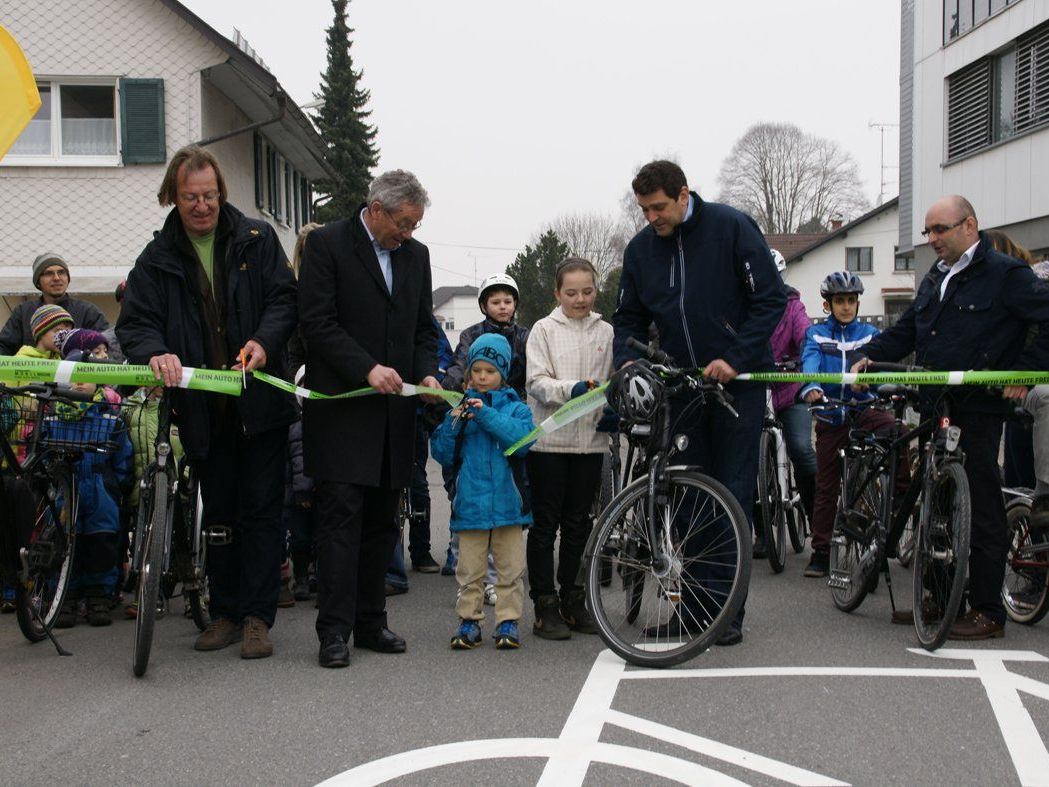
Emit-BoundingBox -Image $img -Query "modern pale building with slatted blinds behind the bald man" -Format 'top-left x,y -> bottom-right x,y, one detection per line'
899,0 -> 1049,275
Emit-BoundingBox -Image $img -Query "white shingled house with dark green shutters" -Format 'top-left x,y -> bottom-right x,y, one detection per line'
0,0 -> 336,321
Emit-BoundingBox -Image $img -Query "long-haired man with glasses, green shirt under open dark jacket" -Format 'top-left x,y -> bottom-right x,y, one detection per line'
116,146 -> 296,658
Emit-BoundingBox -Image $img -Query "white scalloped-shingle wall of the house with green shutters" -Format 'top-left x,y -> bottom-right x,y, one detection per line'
0,0 -> 306,319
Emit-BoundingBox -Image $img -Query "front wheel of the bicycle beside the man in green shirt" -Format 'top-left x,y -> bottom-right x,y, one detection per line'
132,471 -> 170,678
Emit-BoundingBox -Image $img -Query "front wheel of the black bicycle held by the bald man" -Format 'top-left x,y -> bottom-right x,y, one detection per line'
913,462 -> 970,651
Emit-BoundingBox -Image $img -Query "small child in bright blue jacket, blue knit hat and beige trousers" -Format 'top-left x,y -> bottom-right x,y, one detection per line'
431,334 -> 532,651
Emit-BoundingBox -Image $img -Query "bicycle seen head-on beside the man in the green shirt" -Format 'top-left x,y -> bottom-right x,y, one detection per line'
130,389 -> 205,678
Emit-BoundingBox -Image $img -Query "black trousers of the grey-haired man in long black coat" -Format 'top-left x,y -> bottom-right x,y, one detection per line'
314,481 -> 401,640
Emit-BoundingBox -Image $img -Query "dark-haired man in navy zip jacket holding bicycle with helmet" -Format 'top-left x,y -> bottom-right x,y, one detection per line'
612,161 -> 787,644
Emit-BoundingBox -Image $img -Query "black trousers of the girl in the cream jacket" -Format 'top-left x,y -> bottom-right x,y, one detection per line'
527,451 -> 604,600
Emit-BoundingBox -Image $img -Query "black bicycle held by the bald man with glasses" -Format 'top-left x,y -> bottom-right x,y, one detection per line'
814,363 -> 970,651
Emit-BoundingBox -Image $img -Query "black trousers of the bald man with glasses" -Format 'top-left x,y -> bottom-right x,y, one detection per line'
950,412 -> 1009,624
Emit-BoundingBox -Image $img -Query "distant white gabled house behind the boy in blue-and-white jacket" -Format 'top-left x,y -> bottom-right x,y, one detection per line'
785,198 -> 914,323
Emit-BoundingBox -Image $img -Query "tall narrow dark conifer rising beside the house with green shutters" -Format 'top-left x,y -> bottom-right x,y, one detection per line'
315,0 -> 379,221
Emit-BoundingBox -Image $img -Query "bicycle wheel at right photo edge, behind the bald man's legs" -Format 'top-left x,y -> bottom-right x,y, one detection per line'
1002,498 -> 1049,625
